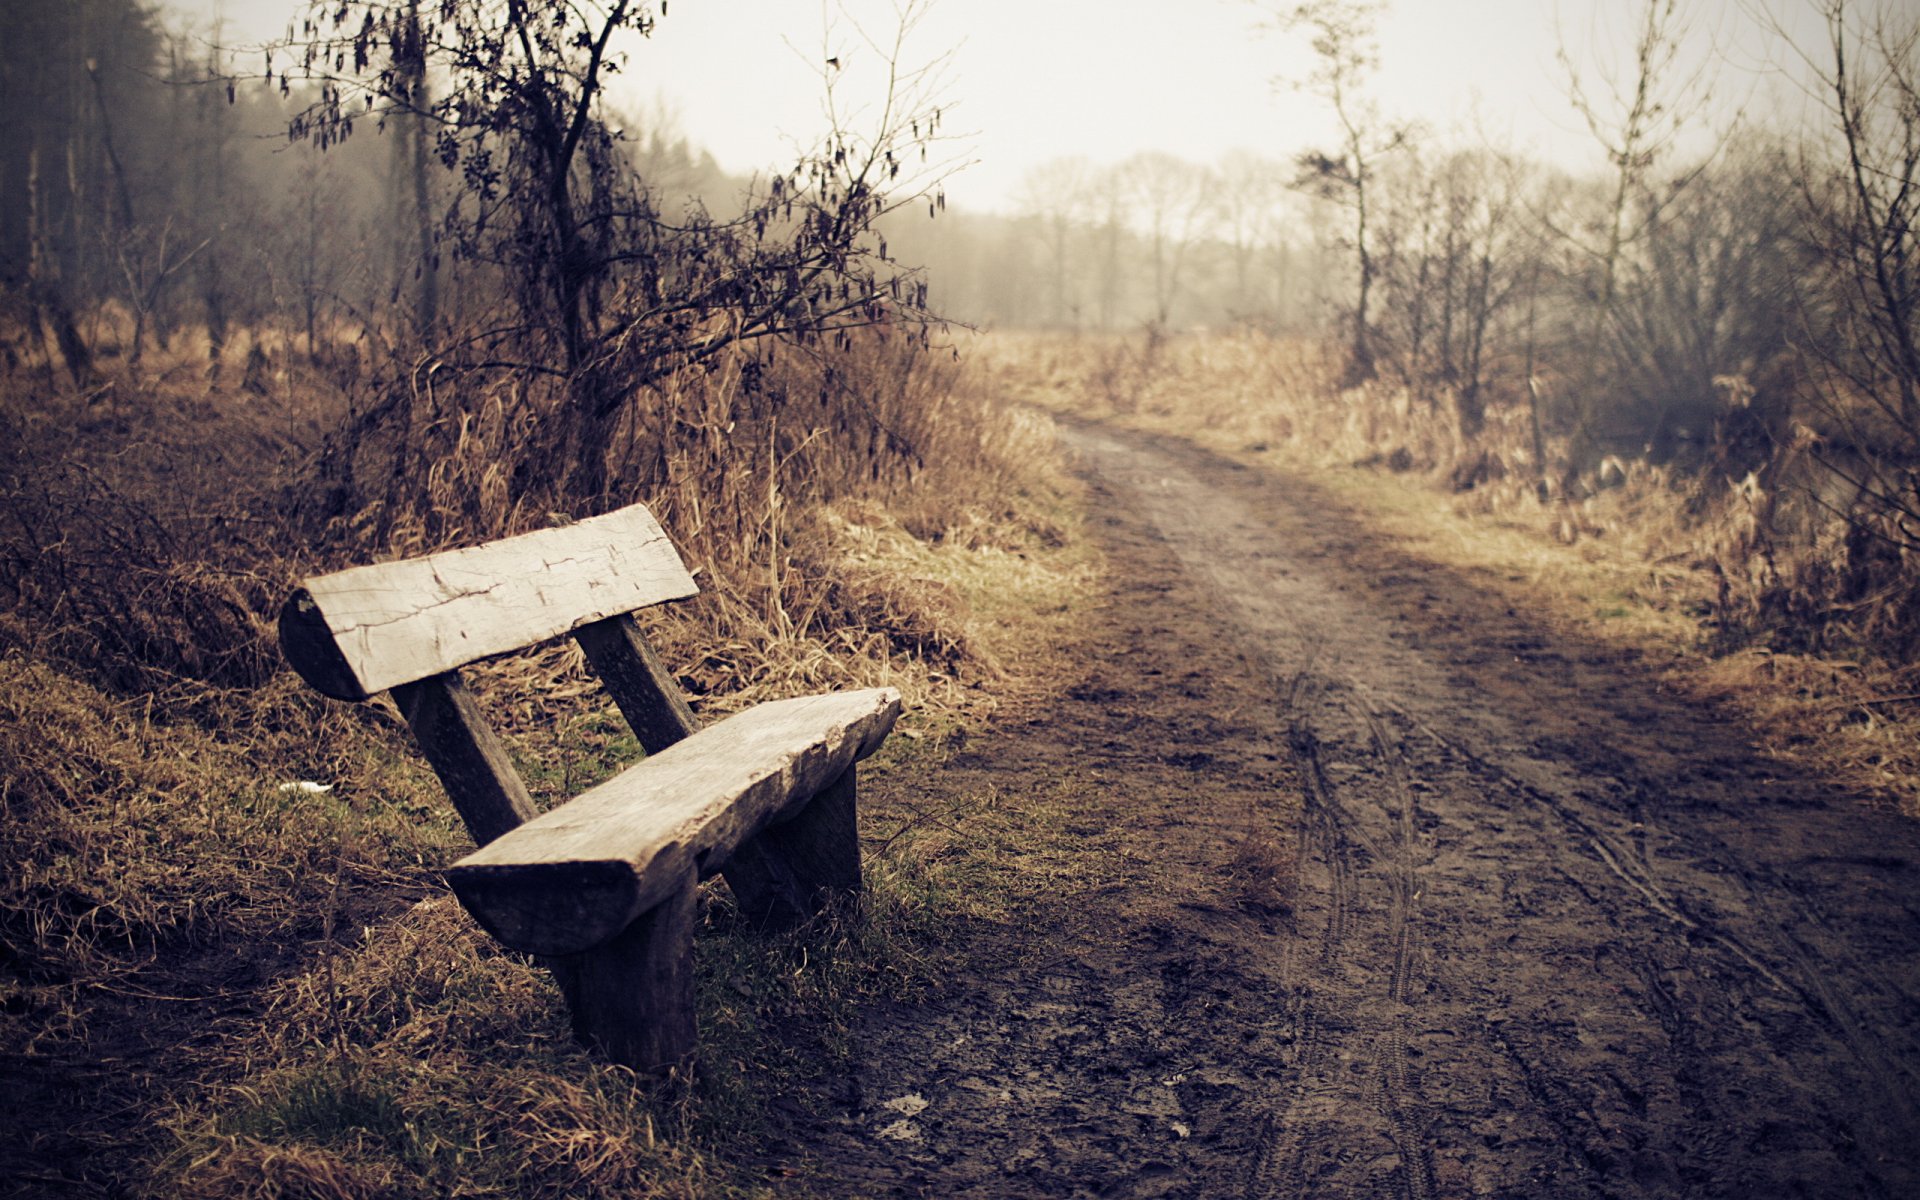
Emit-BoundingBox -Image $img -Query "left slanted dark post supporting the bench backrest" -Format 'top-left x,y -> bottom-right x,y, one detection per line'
394,672 -> 536,847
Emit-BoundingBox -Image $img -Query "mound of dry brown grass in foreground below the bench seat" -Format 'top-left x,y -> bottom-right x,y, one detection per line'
148,897 -> 735,1198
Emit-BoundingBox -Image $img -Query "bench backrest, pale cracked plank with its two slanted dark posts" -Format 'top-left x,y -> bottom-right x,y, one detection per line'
280,505 -> 699,845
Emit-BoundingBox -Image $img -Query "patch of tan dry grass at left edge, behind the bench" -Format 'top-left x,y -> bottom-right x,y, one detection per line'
0,655 -> 455,1050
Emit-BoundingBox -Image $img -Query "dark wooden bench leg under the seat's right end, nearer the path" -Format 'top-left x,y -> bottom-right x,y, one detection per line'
722,766 -> 860,929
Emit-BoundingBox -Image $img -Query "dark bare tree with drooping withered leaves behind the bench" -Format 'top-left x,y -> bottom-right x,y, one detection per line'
269,0 -> 945,503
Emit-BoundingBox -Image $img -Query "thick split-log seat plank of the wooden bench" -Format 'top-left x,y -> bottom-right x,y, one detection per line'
447,687 -> 900,954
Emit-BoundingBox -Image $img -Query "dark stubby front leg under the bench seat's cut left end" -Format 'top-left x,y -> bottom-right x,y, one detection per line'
553,870 -> 697,1073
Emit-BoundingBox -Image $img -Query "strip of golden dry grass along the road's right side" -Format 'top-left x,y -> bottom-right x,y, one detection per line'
979,334 -> 1920,814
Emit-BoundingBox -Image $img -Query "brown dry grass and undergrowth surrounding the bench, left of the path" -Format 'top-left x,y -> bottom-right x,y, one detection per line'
0,322 -> 1096,1196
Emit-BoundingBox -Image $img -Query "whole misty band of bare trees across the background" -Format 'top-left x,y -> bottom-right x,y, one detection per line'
0,0 -> 1920,511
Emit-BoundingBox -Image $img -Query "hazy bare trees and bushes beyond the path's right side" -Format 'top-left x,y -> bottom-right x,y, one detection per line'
913,0 -> 1920,499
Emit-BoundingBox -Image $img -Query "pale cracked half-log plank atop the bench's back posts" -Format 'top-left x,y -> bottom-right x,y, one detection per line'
280,505 -> 699,701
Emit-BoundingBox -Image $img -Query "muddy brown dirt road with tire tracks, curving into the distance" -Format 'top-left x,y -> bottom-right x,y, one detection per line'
785,426 -> 1920,1198
